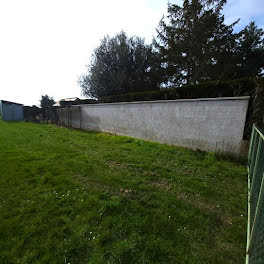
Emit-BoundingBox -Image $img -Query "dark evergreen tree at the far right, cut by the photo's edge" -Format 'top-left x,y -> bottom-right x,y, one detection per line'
236,22 -> 264,78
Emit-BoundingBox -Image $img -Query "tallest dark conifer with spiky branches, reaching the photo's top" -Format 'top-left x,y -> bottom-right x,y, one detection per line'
155,0 -> 237,85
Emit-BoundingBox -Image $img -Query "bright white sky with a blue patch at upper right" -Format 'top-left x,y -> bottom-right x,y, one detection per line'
0,0 -> 264,105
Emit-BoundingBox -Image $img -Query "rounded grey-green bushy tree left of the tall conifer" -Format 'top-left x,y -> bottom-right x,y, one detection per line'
78,32 -> 160,98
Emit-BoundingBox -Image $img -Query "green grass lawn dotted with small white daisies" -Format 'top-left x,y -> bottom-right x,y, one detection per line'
0,121 -> 247,264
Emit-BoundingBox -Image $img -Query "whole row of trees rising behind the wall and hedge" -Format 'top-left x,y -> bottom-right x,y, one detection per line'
78,0 -> 264,98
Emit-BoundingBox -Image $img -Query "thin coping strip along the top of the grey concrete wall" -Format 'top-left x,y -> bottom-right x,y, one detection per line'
67,96 -> 250,107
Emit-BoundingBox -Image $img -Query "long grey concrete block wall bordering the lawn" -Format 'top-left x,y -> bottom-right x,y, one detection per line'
57,97 -> 249,154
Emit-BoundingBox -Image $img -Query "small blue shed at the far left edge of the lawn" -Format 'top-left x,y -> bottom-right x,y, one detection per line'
0,100 -> 24,121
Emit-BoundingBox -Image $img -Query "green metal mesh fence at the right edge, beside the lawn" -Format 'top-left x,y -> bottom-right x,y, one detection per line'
246,125 -> 264,264
